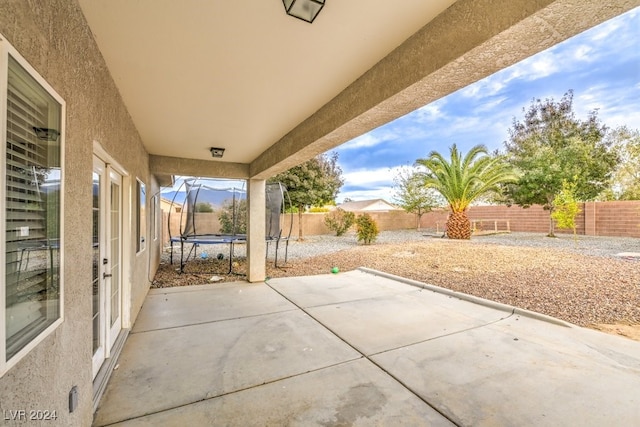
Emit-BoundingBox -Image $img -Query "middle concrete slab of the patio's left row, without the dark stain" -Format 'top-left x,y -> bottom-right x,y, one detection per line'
95,310 -> 360,425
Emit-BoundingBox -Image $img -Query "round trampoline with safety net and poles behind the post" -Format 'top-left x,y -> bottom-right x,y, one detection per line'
168,178 -> 293,274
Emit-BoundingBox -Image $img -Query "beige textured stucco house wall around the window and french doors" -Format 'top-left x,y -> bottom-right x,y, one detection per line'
0,0 -> 161,426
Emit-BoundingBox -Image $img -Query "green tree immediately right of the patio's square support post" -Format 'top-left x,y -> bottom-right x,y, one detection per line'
269,152 -> 344,240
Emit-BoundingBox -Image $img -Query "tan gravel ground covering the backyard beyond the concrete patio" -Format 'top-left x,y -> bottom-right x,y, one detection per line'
154,230 -> 640,338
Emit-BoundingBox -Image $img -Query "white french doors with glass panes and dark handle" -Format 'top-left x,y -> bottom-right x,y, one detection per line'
91,156 -> 123,378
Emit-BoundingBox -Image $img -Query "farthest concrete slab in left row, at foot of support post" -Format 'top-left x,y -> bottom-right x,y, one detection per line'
132,282 -> 296,333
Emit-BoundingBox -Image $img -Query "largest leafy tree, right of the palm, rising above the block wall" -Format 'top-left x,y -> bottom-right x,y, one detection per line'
505,91 -> 618,236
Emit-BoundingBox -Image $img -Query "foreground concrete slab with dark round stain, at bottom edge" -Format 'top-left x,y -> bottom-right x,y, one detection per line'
107,359 -> 454,427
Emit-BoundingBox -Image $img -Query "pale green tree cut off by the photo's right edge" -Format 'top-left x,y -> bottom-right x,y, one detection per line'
600,126 -> 640,200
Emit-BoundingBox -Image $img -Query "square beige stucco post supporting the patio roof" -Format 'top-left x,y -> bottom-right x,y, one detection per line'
247,179 -> 267,283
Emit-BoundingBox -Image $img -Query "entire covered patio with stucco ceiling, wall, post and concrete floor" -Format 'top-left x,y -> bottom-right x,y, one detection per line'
0,0 -> 640,427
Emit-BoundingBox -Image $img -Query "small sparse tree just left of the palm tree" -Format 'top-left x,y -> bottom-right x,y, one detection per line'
393,167 -> 442,228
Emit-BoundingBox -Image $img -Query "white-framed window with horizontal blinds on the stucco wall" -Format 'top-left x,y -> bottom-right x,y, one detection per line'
4,56 -> 62,360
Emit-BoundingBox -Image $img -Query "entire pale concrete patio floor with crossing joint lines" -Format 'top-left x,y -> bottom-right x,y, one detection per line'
94,269 -> 640,426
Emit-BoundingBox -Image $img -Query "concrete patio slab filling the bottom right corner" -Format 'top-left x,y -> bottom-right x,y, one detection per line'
372,316 -> 640,426
